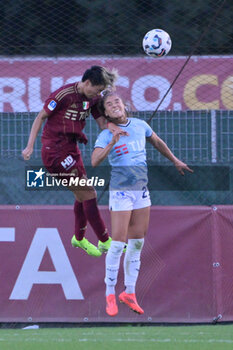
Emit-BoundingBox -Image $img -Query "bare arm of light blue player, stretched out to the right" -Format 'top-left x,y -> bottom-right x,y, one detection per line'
148,132 -> 193,175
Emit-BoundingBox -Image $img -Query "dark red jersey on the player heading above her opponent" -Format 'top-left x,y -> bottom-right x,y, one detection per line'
41,83 -> 101,145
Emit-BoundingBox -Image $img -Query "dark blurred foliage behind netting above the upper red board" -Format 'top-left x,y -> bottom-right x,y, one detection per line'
0,0 -> 233,56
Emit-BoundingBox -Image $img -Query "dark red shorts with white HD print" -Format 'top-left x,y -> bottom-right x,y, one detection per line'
41,145 -> 86,179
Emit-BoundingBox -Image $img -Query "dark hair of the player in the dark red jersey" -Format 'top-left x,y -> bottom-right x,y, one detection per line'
82,66 -> 118,88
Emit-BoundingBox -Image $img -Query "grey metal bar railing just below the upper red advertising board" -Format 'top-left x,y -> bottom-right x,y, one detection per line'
0,111 -> 233,164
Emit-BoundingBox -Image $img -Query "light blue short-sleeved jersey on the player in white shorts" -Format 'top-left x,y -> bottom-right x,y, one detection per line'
95,118 -> 153,190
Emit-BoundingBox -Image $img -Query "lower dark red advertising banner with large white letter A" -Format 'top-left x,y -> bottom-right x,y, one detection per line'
0,206 -> 233,323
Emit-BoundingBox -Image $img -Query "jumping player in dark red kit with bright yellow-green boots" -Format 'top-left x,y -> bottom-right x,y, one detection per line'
22,66 -> 125,256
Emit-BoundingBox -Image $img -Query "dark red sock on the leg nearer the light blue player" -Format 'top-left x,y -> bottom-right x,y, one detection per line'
83,198 -> 109,242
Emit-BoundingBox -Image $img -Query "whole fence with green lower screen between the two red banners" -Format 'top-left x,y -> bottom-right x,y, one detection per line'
0,110 -> 233,205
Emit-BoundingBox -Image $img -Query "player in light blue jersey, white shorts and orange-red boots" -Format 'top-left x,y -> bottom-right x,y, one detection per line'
92,91 -> 193,316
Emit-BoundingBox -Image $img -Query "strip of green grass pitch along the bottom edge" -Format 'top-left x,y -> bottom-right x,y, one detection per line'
0,324 -> 233,350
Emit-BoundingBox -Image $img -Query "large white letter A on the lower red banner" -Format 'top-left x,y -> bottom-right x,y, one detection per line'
9,228 -> 84,300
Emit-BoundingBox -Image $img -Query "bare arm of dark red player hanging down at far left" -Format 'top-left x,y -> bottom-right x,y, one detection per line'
22,109 -> 48,160
